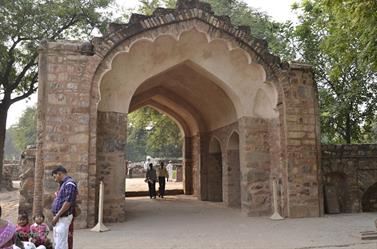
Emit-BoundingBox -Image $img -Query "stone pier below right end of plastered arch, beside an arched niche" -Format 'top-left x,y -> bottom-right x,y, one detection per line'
239,117 -> 272,216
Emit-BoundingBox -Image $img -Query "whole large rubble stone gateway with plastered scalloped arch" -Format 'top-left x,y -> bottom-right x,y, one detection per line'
34,0 -> 323,227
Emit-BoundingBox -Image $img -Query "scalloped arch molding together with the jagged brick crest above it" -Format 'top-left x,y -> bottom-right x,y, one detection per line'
92,0 -> 288,120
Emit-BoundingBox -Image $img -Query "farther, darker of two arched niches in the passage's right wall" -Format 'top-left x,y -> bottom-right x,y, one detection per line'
206,138 -> 223,201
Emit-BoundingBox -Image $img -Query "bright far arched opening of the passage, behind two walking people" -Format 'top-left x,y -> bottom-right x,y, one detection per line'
126,106 -> 185,197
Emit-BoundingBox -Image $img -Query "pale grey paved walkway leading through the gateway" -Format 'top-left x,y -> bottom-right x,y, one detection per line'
75,196 -> 377,249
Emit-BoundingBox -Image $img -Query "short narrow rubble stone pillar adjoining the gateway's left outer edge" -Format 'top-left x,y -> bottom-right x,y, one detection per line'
18,147 -> 36,215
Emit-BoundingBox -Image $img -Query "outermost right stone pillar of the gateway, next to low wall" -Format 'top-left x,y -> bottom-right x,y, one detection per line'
285,64 -> 322,217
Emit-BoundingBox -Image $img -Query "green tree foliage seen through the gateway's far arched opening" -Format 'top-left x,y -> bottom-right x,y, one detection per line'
126,107 -> 182,161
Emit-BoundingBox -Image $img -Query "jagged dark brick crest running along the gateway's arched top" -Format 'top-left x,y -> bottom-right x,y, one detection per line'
92,0 -> 283,78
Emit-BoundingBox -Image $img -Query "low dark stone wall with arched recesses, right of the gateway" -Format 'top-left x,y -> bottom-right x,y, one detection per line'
322,144 -> 377,213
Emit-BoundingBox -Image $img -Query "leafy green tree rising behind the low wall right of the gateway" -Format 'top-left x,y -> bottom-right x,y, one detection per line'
289,0 -> 377,143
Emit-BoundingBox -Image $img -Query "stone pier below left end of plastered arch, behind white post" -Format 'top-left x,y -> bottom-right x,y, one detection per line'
97,111 -> 127,222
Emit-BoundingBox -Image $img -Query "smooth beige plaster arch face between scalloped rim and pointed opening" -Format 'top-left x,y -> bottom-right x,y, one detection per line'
95,27 -> 276,121
